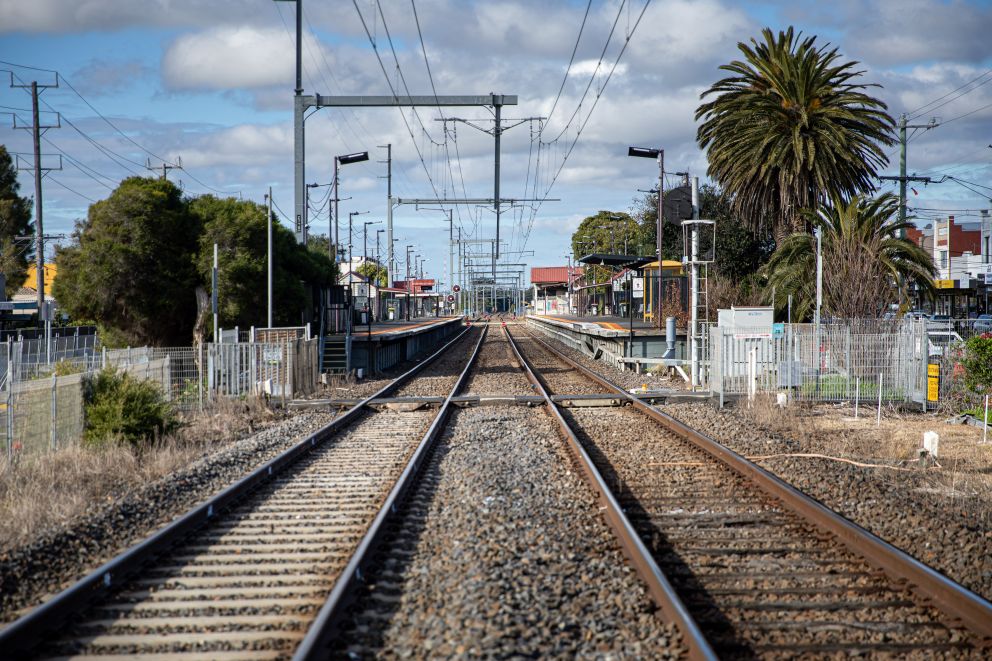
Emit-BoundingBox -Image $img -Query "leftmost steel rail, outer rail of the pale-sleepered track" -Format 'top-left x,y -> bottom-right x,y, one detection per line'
0,327 -> 471,652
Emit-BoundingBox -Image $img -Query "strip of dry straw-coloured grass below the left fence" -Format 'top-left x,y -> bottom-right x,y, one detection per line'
0,400 -> 275,551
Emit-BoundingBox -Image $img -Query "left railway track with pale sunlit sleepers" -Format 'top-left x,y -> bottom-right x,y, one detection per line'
0,322 -> 485,659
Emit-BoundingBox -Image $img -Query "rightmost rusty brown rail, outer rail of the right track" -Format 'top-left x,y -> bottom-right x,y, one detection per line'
532,328 -> 992,647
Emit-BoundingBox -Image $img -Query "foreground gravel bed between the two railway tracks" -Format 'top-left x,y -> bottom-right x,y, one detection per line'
339,407 -> 683,658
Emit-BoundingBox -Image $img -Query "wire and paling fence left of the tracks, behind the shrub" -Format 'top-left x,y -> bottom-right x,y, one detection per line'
0,338 -> 318,458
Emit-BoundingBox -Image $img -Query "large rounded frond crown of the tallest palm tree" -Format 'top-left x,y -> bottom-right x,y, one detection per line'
696,27 -> 894,241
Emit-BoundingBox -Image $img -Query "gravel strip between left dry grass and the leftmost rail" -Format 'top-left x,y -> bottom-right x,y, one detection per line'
0,410 -> 334,622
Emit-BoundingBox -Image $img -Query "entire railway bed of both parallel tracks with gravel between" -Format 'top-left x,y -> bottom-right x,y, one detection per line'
7,318 -> 992,659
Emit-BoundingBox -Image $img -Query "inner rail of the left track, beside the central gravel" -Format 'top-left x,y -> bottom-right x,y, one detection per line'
293,326 -> 489,661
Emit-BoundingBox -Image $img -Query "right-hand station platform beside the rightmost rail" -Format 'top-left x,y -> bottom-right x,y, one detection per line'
527,315 -> 688,372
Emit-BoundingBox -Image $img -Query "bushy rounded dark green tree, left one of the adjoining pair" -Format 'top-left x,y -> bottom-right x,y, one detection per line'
54,177 -> 201,346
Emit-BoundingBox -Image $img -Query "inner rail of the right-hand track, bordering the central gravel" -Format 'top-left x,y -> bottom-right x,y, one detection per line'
503,326 -> 718,659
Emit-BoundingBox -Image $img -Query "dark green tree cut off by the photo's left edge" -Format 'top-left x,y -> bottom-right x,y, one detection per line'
0,145 -> 34,298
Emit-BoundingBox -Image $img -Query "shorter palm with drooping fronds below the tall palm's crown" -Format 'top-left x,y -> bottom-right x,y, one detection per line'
765,193 -> 937,319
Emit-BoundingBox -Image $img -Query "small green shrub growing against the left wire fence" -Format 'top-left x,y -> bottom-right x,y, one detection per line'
83,367 -> 178,446
